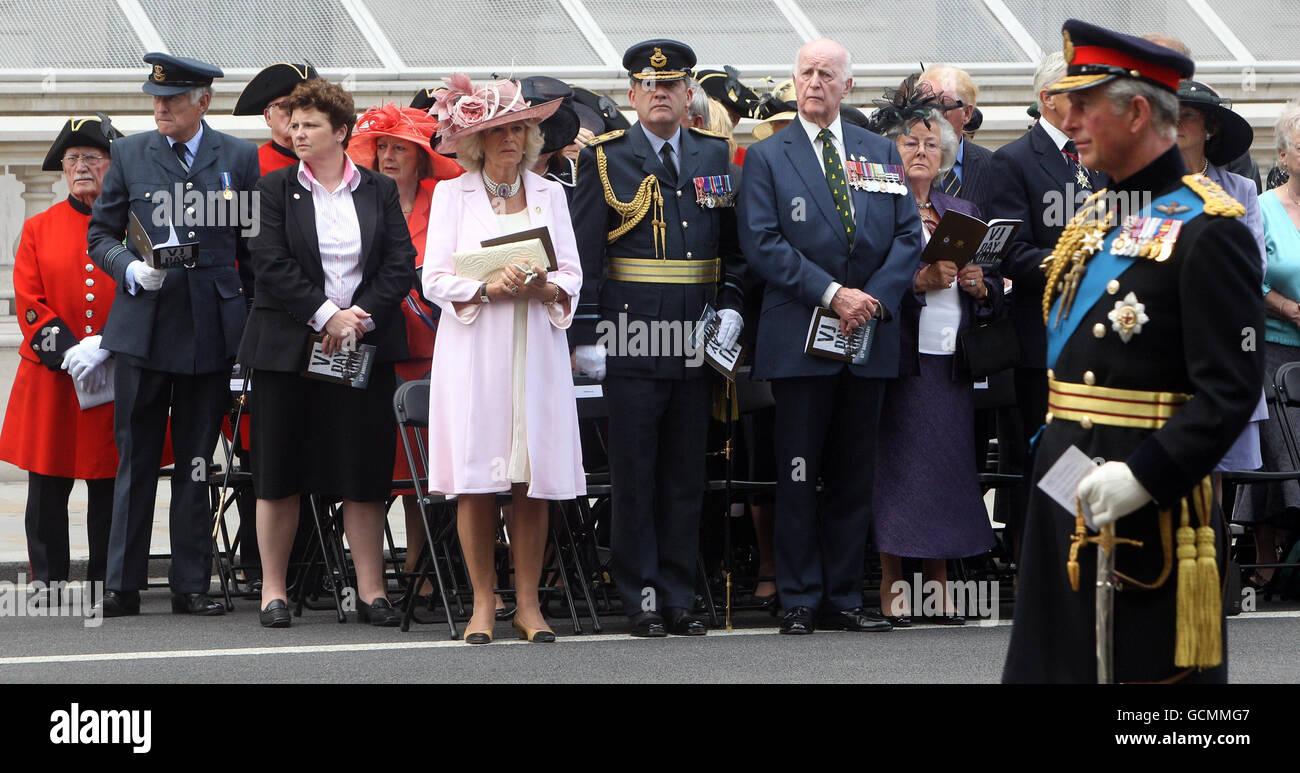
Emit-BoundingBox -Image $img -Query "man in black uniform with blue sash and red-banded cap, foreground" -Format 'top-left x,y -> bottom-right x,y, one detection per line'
1004,19 -> 1264,682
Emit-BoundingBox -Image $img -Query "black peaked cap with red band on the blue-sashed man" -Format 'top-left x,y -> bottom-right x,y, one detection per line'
1048,18 -> 1196,94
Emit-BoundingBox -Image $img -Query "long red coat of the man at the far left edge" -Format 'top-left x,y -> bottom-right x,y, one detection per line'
0,199 -> 117,479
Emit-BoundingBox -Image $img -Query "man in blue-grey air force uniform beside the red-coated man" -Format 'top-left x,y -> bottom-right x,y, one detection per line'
86,53 -> 259,617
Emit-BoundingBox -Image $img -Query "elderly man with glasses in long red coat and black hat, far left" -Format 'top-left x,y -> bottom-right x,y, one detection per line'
0,114 -> 122,585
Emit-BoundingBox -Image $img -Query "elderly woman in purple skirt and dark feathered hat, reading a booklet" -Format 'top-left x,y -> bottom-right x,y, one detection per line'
872,86 -> 1002,626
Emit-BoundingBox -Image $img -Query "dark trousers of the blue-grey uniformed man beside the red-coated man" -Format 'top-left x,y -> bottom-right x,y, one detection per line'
105,357 -> 230,594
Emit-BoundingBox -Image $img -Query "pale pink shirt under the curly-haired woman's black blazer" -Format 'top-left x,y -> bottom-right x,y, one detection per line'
298,156 -> 374,333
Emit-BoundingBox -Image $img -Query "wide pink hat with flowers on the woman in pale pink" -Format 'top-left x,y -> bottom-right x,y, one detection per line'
429,73 -> 564,153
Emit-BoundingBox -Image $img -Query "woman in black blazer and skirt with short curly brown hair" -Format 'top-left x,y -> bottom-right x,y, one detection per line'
239,79 -> 415,627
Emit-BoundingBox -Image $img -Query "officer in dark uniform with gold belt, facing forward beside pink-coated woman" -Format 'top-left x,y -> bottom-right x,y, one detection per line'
571,40 -> 742,637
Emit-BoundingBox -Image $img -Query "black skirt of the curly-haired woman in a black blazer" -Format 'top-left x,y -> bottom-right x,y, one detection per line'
248,362 -> 397,501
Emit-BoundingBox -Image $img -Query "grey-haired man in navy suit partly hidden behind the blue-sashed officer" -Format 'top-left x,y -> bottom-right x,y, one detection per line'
983,52 -> 1105,548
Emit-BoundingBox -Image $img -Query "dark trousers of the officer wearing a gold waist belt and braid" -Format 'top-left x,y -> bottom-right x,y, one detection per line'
605,375 -> 711,616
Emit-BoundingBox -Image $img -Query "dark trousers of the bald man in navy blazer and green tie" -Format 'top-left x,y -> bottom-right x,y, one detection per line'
772,368 -> 884,612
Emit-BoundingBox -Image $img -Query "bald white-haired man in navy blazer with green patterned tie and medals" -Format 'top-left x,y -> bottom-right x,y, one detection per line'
740,39 -> 920,634
